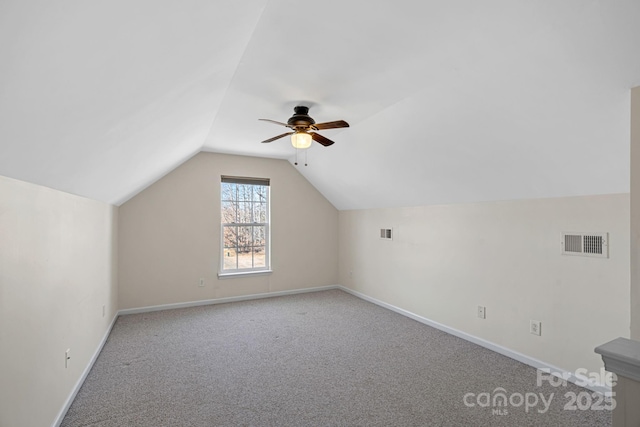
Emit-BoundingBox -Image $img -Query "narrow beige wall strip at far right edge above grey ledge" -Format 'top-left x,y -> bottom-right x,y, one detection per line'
632,87 -> 640,341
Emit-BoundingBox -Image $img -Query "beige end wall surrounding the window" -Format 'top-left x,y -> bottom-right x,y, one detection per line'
119,153 -> 338,309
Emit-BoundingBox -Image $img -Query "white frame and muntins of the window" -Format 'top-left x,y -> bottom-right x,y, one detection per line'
218,176 -> 271,278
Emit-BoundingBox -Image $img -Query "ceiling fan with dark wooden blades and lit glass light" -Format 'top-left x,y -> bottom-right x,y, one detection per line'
260,105 -> 349,148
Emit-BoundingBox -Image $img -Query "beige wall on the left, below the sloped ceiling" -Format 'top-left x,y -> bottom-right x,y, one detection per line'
0,177 -> 117,427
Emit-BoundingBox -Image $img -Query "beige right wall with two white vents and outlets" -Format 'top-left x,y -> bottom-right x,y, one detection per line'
339,194 -> 629,378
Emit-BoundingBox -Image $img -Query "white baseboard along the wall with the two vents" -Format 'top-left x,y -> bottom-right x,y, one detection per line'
337,285 -> 611,395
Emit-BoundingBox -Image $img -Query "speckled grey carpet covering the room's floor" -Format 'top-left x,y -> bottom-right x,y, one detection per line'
62,290 -> 611,427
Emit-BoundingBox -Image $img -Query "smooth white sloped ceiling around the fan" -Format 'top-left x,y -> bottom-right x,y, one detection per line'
0,0 -> 640,209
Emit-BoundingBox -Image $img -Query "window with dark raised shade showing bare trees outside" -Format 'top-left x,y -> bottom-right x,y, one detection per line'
220,176 -> 270,274
